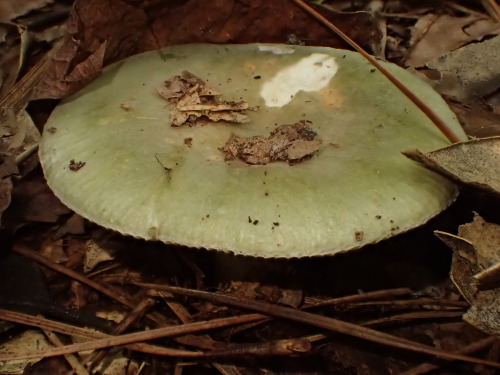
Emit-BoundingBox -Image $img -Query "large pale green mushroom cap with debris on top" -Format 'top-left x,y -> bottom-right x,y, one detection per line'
39,44 -> 466,258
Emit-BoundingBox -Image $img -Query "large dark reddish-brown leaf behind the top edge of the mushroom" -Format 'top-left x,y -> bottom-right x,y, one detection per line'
33,0 -> 381,99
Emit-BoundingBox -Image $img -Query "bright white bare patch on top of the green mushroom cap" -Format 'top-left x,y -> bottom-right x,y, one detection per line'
260,53 -> 339,107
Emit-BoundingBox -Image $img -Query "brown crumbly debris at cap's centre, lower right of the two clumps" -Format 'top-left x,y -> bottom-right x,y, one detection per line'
220,121 -> 321,164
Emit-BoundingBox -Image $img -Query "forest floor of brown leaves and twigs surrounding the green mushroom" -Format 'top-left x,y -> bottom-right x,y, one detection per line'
0,0 -> 500,375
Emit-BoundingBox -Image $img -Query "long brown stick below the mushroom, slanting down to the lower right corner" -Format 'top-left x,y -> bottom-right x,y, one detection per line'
140,283 -> 500,368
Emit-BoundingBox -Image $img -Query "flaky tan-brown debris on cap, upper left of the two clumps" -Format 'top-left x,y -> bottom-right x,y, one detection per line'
156,71 -> 253,126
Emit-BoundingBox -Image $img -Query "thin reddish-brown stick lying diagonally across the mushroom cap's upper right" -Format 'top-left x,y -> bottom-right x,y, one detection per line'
292,0 -> 461,143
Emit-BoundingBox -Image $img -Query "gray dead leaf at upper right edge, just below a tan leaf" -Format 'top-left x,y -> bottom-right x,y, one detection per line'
427,35 -> 500,103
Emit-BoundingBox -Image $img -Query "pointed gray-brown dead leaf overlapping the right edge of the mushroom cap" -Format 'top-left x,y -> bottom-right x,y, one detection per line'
403,136 -> 500,194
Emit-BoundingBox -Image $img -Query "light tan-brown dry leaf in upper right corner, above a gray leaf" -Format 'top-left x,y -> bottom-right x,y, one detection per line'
406,14 -> 500,67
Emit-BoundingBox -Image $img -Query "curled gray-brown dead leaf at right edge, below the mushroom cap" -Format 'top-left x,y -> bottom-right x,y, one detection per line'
436,215 -> 500,335
